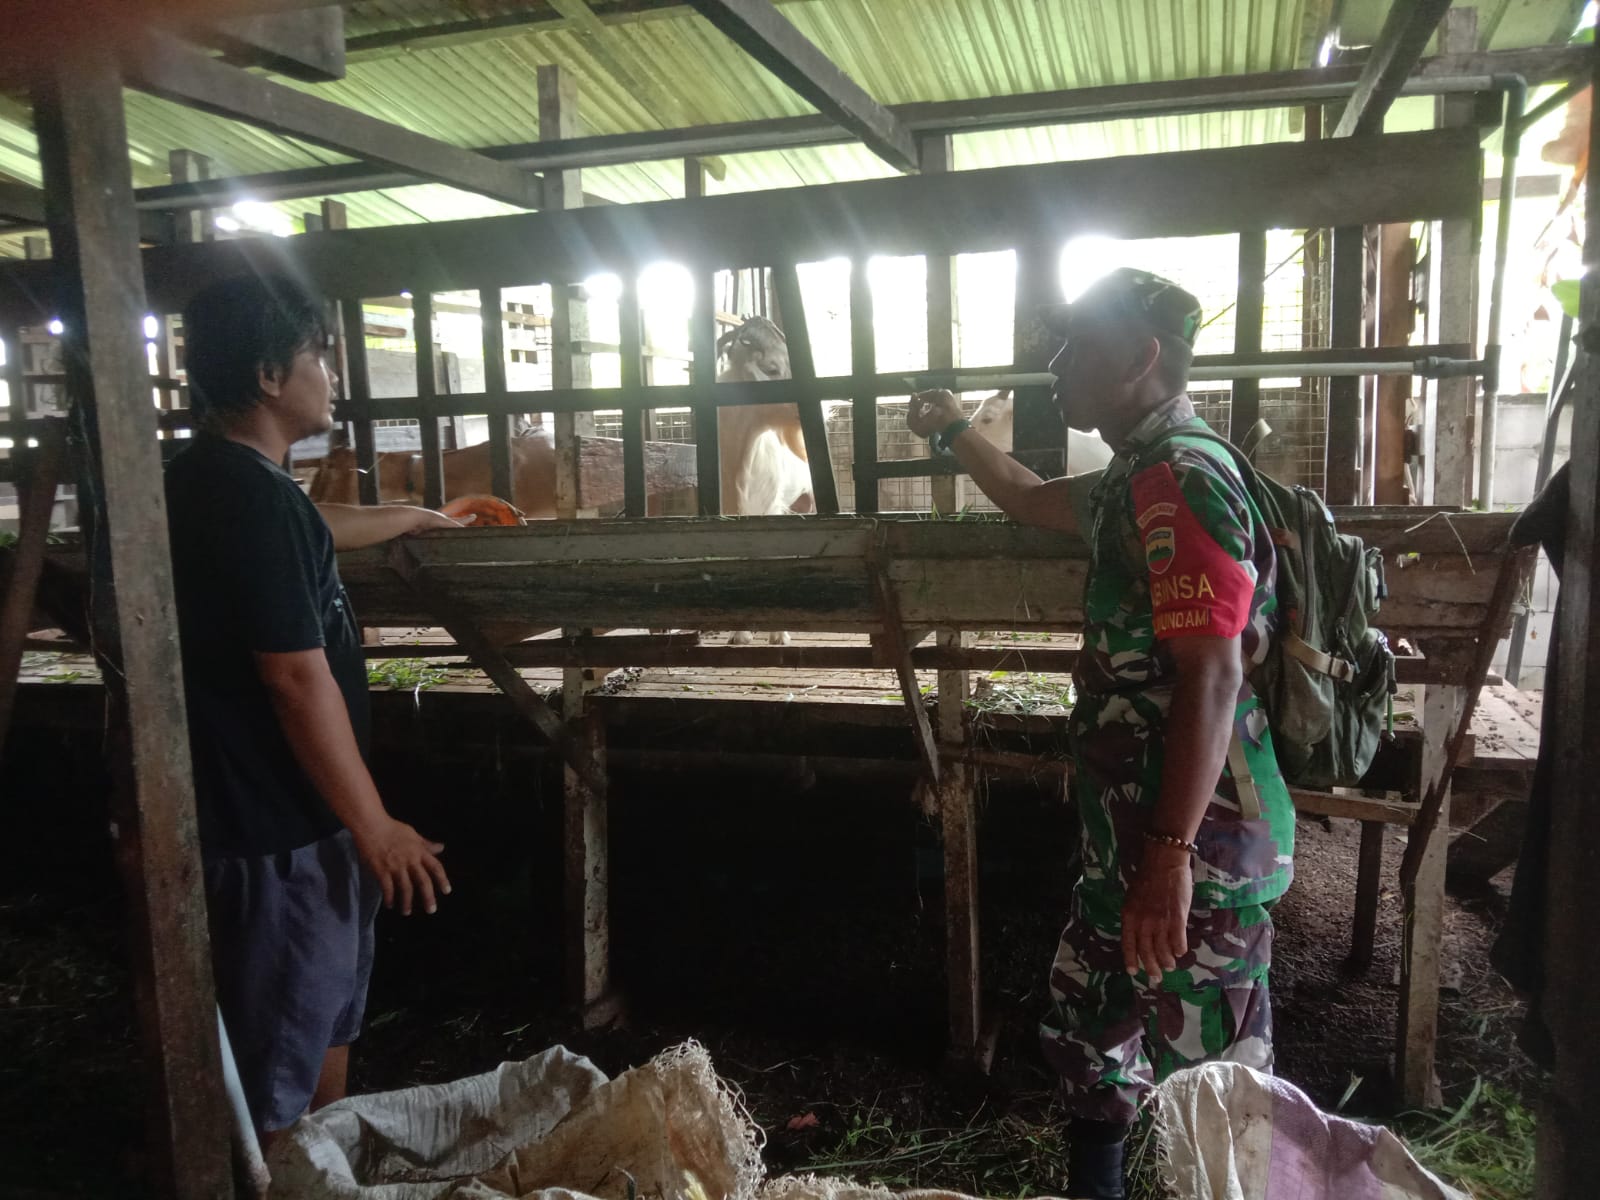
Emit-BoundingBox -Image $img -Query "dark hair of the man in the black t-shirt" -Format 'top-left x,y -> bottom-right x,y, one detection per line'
184,275 -> 330,419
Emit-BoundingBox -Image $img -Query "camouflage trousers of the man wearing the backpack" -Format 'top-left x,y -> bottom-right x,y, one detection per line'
1040,894 -> 1272,1125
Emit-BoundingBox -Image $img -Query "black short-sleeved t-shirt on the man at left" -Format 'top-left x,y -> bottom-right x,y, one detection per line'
166,435 -> 371,856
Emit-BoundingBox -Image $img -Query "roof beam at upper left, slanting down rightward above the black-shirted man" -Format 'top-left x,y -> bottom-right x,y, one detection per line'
123,32 -> 544,208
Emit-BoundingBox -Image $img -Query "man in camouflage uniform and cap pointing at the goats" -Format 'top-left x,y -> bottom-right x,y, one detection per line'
910,269 -> 1294,1197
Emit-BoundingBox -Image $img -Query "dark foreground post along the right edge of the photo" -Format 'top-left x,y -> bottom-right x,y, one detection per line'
1534,28 -> 1600,1200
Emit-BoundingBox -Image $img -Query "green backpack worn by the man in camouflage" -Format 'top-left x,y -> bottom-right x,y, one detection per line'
1134,427 -> 1395,787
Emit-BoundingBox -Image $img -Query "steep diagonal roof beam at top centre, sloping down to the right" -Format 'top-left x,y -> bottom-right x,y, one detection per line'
690,0 -> 917,171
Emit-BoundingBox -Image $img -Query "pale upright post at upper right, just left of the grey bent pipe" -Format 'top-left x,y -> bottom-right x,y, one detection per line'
1424,8 -> 1483,507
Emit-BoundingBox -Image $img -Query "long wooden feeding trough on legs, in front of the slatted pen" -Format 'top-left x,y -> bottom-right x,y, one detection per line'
324,507 -> 1528,1107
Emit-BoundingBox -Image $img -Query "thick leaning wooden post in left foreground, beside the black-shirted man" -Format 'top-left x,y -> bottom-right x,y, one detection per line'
34,45 -> 234,1200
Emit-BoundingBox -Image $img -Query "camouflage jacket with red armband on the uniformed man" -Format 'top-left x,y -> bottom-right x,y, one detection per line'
1070,397 -> 1294,920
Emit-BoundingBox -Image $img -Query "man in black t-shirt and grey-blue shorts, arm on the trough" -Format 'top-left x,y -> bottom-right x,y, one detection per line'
166,275 -> 456,1136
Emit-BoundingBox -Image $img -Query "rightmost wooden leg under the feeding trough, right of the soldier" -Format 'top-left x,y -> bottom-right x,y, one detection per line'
1395,683 -> 1464,1109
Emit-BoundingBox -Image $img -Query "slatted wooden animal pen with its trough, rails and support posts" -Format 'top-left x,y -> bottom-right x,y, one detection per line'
0,5 -> 1600,1195
